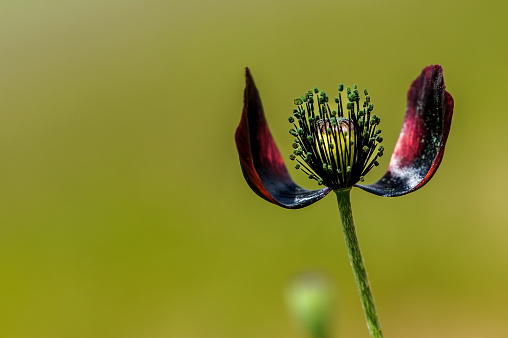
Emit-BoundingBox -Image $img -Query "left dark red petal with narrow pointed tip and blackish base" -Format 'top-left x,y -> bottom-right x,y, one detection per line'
235,68 -> 330,209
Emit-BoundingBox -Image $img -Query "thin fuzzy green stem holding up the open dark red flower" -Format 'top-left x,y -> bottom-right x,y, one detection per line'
335,189 -> 383,338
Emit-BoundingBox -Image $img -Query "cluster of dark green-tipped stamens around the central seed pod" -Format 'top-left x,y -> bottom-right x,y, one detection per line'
289,83 -> 384,190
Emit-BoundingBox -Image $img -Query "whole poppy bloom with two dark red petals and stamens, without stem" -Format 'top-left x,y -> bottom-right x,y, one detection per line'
235,65 -> 453,208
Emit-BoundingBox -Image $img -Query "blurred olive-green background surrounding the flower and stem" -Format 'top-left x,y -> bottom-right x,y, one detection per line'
0,0 -> 508,338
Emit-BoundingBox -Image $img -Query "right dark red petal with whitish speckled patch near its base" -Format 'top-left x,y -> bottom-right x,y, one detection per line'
357,65 -> 453,196
